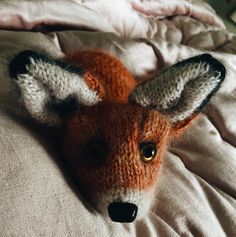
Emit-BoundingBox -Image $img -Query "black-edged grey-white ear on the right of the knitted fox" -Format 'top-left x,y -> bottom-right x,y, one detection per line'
130,54 -> 225,123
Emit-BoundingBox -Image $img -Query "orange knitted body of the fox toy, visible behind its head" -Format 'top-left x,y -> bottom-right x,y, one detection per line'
66,50 -> 137,103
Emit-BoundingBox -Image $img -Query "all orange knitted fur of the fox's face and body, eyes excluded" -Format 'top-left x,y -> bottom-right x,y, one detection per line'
63,50 -> 189,191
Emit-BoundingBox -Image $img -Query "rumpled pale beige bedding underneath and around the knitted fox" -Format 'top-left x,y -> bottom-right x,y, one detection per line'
0,0 -> 236,237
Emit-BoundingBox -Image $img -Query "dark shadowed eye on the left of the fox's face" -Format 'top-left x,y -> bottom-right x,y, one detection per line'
84,140 -> 108,167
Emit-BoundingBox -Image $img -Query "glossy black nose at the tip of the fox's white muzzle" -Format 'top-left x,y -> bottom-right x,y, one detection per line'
108,202 -> 138,223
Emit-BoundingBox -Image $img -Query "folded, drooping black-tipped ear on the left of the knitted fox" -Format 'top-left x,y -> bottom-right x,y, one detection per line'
9,50 -> 100,125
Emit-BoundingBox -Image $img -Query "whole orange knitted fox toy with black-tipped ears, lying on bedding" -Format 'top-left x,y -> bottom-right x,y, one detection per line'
9,50 -> 225,222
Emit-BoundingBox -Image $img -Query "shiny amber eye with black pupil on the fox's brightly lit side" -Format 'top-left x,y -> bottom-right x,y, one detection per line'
139,142 -> 157,162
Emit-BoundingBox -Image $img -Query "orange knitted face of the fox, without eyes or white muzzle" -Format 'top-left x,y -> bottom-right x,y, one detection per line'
67,103 -> 171,191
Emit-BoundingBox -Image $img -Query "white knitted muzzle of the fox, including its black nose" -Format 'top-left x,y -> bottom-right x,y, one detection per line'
87,185 -> 155,223
